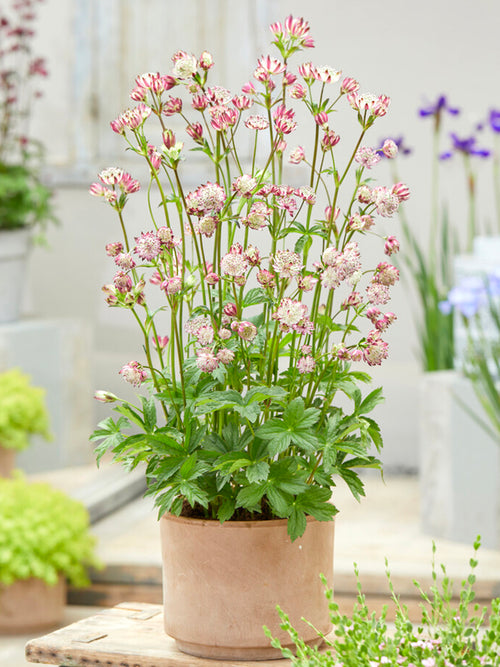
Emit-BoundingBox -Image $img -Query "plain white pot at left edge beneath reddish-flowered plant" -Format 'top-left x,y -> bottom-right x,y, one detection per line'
0,229 -> 31,324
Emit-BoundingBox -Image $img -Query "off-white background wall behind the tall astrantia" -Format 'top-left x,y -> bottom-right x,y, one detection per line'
23,0 -> 500,469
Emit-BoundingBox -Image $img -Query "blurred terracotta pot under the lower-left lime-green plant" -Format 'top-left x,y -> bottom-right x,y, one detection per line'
0,577 -> 66,634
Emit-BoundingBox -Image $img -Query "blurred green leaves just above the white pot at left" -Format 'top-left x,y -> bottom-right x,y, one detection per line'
0,163 -> 55,230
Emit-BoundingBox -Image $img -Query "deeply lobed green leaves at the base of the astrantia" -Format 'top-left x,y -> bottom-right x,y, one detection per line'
91,365 -> 382,539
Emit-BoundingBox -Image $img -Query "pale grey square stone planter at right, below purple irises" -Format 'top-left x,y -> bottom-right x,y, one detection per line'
420,371 -> 500,549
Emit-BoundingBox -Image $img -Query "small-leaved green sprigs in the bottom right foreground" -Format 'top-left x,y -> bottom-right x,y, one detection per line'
264,538 -> 500,667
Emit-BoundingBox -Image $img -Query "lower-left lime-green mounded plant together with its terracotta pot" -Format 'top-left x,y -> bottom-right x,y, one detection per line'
0,477 -> 99,633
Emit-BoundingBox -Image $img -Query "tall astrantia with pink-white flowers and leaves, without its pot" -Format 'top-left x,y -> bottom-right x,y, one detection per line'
90,16 -> 409,538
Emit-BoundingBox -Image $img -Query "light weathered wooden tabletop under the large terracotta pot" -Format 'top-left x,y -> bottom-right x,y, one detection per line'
26,602 -> 290,667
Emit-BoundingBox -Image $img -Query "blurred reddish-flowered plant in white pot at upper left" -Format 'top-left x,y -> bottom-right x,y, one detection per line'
0,0 -> 55,323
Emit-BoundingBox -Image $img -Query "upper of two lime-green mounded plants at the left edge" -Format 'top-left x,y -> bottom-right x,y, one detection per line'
0,368 -> 51,477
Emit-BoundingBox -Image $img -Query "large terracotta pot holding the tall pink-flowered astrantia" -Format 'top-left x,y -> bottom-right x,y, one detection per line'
160,514 -> 334,660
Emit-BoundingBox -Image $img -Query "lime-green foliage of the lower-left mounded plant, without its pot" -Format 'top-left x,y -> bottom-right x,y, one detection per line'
0,477 -> 99,586
